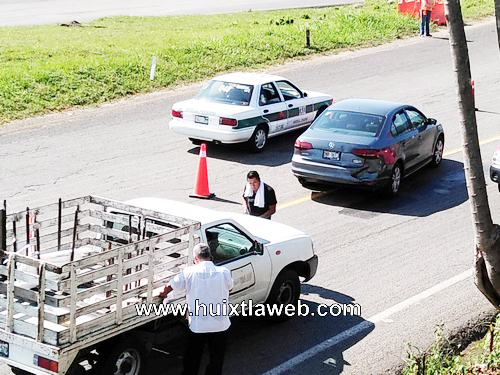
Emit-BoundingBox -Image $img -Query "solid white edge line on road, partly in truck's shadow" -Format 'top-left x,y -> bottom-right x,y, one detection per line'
264,268 -> 473,375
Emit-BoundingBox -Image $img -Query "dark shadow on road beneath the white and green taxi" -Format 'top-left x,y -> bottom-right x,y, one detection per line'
188,129 -> 305,167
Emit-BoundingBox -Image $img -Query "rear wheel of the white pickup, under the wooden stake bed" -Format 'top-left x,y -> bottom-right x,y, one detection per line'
97,338 -> 146,375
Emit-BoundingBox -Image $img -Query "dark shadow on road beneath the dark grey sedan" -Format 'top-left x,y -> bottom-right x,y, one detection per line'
311,159 -> 468,219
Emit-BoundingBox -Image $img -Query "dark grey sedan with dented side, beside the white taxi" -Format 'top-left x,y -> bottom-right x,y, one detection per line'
292,99 -> 444,196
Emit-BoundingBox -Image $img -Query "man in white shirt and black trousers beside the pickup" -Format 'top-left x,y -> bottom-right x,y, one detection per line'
160,243 -> 233,375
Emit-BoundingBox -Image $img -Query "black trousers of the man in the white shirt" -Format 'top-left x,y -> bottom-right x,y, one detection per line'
182,330 -> 227,375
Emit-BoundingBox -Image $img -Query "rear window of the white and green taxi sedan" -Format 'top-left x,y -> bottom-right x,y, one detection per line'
195,80 -> 253,106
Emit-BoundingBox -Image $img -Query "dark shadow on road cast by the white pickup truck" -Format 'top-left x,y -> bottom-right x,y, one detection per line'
146,284 -> 374,375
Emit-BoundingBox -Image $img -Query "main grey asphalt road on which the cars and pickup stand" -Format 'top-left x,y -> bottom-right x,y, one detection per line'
0,20 -> 500,375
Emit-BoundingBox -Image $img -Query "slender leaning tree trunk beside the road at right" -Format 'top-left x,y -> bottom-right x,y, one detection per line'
445,0 -> 500,309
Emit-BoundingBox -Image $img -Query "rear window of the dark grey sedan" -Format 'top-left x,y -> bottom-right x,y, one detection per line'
311,110 -> 384,137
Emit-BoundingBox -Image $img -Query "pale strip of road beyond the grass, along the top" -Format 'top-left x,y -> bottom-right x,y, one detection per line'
0,0 -> 355,26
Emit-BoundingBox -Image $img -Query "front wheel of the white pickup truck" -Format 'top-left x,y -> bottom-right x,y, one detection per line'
266,270 -> 300,323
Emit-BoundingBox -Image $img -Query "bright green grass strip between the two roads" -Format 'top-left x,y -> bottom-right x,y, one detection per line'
0,0 -> 493,124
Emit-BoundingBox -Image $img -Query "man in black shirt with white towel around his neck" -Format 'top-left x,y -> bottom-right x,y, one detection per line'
243,171 -> 277,219
